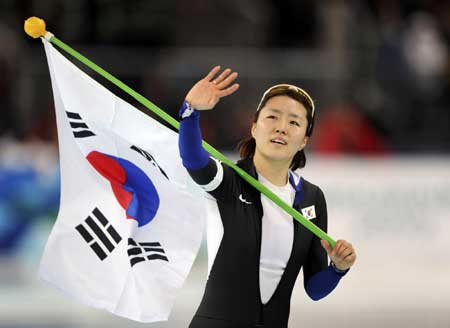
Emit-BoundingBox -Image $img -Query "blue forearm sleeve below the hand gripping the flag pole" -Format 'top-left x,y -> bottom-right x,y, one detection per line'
305,265 -> 349,301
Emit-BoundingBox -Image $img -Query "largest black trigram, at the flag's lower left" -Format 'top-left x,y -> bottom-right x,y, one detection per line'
75,208 -> 122,261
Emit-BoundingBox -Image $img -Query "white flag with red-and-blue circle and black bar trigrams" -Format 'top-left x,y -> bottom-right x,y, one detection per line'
40,40 -> 205,322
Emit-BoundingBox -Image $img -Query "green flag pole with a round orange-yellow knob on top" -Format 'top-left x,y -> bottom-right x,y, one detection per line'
24,17 -> 336,247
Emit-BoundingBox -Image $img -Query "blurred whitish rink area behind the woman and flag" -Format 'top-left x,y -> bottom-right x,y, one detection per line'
0,156 -> 450,328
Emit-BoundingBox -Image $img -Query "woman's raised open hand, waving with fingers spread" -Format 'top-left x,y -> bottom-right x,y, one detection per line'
186,66 -> 239,110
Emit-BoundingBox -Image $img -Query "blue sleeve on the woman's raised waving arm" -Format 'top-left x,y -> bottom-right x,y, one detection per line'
178,101 -> 209,170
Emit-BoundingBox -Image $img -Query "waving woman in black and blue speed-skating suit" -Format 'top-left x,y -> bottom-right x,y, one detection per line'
179,66 -> 356,328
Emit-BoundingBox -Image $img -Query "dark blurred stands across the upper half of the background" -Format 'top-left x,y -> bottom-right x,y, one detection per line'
0,0 -> 450,157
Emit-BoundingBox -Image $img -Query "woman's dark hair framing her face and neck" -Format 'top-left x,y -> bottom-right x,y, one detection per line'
238,89 -> 314,170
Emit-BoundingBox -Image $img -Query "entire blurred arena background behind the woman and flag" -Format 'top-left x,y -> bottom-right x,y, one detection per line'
0,0 -> 450,328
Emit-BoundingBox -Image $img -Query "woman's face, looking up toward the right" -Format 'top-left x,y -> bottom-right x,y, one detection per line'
252,95 -> 308,163
